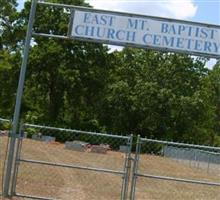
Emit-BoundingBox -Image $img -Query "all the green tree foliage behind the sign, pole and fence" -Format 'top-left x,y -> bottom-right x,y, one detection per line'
0,0 -> 220,147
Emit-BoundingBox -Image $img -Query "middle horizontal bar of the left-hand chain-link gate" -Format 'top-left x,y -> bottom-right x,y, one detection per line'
18,159 -> 125,175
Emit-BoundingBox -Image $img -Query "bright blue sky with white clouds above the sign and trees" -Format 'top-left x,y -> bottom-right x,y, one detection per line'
18,0 -> 220,68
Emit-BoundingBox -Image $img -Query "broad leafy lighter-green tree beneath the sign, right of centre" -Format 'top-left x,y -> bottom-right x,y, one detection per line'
101,48 -> 216,143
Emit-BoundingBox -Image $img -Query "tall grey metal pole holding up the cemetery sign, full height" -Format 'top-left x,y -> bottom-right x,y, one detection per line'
3,0 -> 37,197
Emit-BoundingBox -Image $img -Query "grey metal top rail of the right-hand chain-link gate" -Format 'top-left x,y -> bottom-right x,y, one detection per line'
140,138 -> 220,151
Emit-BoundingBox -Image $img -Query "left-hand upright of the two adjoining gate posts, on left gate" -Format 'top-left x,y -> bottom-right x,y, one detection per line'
121,135 -> 133,200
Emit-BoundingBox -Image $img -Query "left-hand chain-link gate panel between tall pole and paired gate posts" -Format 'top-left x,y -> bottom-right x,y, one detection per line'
14,124 -> 132,200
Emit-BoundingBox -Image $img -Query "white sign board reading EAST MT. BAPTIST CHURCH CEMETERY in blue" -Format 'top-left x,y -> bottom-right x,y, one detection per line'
69,9 -> 220,58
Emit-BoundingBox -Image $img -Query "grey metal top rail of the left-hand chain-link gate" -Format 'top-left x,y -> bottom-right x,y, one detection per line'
24,123 -> 131,139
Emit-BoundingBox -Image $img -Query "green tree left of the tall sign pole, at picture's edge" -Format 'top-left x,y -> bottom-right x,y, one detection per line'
0,0 -> 20,118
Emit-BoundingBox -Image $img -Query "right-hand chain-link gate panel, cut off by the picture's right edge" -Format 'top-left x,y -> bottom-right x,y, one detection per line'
131,137 -> 220,200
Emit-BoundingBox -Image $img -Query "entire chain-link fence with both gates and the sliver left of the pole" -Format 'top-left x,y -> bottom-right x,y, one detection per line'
0,118 -> 220,200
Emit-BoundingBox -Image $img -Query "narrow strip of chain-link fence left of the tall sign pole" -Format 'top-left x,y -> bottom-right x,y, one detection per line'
0,118 -> 11,196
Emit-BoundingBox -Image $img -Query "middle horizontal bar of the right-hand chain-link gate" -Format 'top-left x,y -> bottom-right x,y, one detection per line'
135,173 -> 220,186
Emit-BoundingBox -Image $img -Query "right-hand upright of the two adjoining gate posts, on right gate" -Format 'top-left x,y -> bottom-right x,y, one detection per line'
130,135 -> 141,200
